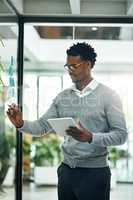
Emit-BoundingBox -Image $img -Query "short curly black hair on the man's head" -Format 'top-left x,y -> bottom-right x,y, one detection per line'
67,42 -> 97,68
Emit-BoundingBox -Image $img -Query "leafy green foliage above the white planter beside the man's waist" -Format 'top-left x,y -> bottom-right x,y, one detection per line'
33,134 -> 62,166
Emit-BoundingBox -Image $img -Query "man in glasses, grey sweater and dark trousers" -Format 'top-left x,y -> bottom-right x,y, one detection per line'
7,43 -> 127,200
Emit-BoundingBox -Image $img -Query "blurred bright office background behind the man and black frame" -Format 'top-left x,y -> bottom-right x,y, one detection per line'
0,0 -> 133,200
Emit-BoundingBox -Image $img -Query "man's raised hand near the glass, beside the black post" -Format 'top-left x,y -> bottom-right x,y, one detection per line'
7,103 -> 24,128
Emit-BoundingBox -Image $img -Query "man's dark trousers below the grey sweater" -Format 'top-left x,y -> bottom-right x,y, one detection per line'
57,163 -> 111,200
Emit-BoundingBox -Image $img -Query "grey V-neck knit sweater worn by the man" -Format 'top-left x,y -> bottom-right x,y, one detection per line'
19,84 -> 127,168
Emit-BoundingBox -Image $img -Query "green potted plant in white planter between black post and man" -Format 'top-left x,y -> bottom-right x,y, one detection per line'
33,134 -> 62,185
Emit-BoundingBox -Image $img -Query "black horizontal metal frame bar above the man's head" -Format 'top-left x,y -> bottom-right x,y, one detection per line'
23,15 -> 133,24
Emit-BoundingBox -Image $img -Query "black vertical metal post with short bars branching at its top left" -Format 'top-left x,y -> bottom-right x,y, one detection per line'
0,0 -> 24,200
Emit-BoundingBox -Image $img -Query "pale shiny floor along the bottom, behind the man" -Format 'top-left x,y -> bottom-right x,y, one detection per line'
0,184 -> 133,200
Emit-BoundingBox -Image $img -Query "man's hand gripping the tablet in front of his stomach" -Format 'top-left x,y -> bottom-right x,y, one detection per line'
66,121 -> 92,143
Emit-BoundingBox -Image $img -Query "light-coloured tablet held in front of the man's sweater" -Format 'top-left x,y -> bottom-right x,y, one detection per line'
47,117 -> 76,136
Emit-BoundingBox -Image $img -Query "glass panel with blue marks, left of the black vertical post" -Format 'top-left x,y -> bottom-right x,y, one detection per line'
0,23 -> 18,199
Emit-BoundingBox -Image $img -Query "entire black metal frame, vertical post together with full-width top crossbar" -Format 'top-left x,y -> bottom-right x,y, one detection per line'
0,0 -> 133,200
